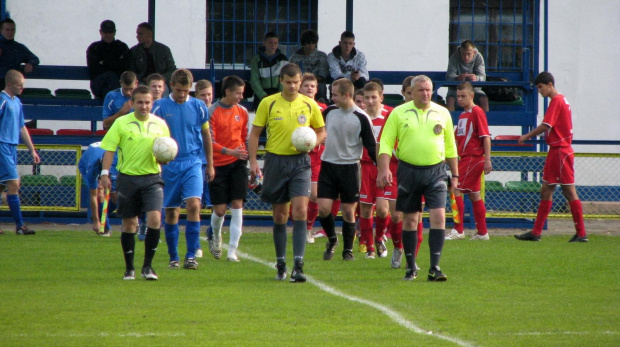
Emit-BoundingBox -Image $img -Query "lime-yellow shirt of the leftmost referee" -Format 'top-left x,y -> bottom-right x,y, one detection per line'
100,112 -> 170,176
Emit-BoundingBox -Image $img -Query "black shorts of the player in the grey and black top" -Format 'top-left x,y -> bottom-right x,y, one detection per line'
317,161 -> 360,203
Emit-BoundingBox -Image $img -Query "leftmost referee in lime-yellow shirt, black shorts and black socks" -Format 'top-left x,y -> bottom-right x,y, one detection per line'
100,86 -> 170,280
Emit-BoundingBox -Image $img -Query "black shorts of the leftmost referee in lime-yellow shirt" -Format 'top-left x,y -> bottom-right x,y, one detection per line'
116,173 -> 164,218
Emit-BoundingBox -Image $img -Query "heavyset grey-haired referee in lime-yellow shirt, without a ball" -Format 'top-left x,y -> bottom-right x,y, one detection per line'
377,75 -> 459,281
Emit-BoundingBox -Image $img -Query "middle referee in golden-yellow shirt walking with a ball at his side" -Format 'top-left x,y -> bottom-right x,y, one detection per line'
248,64 -> 325,282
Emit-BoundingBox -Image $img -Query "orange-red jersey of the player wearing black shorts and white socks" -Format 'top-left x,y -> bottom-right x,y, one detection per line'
209,101 -> 248,166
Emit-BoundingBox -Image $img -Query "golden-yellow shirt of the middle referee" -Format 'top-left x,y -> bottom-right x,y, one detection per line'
252,93 -> 325,155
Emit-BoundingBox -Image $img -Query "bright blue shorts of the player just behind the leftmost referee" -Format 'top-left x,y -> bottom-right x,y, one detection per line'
162,159 -> 204,208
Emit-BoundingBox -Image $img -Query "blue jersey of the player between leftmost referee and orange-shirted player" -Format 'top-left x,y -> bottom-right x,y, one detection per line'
153,94 -> 209,160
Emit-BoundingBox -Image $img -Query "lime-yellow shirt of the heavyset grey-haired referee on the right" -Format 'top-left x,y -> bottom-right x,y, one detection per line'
379,101 -> 457,166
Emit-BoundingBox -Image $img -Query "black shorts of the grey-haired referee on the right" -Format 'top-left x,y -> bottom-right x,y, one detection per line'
396,161 -> 448,213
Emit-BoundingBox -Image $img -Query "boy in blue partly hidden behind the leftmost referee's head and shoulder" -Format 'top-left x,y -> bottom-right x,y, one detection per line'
102,71 -> 138,129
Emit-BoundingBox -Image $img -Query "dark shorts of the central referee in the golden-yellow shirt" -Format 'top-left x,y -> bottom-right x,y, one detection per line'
260,153 -> 312,204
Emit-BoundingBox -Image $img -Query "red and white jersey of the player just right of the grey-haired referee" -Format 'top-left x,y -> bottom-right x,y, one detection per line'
454,105 -> 491,158
